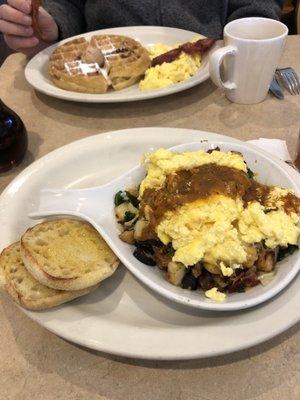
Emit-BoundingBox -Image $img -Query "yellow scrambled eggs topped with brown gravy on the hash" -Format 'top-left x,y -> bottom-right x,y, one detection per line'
140,149 -> 300,268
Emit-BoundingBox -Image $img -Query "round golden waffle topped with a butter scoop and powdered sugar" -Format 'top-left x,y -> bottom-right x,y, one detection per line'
49,35 -> 151,93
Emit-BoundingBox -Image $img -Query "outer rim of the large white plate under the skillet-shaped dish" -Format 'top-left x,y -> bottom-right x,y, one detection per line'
0,128 -> 300,360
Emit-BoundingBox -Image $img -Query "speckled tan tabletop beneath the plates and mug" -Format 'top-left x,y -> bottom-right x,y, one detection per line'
0,36 -> 300,400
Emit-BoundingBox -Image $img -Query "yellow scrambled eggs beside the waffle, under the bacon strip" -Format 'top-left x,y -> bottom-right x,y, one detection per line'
139,37 -> 201,90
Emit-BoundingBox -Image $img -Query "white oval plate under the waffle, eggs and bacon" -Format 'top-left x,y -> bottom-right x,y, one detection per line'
25,26 -> 217,103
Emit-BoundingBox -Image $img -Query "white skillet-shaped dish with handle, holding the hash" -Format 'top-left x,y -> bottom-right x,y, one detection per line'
31,140 -> 300,311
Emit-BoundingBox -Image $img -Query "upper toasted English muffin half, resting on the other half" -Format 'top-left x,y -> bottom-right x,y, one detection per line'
21,219 -> 119,290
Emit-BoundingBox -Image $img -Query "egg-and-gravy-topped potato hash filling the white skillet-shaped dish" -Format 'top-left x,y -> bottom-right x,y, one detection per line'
114,148 -> 300,301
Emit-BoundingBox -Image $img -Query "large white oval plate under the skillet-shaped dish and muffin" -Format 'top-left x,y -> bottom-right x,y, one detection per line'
0,128 -> 300,359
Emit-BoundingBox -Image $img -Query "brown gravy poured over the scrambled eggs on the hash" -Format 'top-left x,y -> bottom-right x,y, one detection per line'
140,164 -> 300,237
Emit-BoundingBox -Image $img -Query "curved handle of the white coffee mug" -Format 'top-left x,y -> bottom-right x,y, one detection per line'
209,46 -> 237,90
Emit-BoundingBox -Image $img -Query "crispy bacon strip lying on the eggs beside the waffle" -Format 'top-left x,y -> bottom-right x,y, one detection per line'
151,38 -> 216,67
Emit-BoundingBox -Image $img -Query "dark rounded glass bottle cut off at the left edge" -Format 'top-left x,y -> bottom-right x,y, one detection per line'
0,100 -> 28,173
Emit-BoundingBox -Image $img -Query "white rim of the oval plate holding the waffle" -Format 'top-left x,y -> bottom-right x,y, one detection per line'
25,25 -> 220,103
